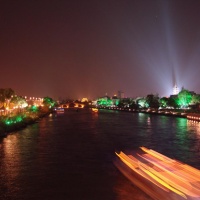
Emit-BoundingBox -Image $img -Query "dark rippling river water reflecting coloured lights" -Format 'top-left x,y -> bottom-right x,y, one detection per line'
0,110 -> 200,200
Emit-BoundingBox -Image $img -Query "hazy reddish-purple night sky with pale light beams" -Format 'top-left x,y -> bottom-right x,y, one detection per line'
0,0 -> 200,99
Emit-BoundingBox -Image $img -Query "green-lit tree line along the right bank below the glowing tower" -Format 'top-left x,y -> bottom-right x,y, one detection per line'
97,88 -> 200,109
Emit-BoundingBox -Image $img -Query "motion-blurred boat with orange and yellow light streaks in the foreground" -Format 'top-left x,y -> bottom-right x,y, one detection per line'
115,147 -> 200,200
